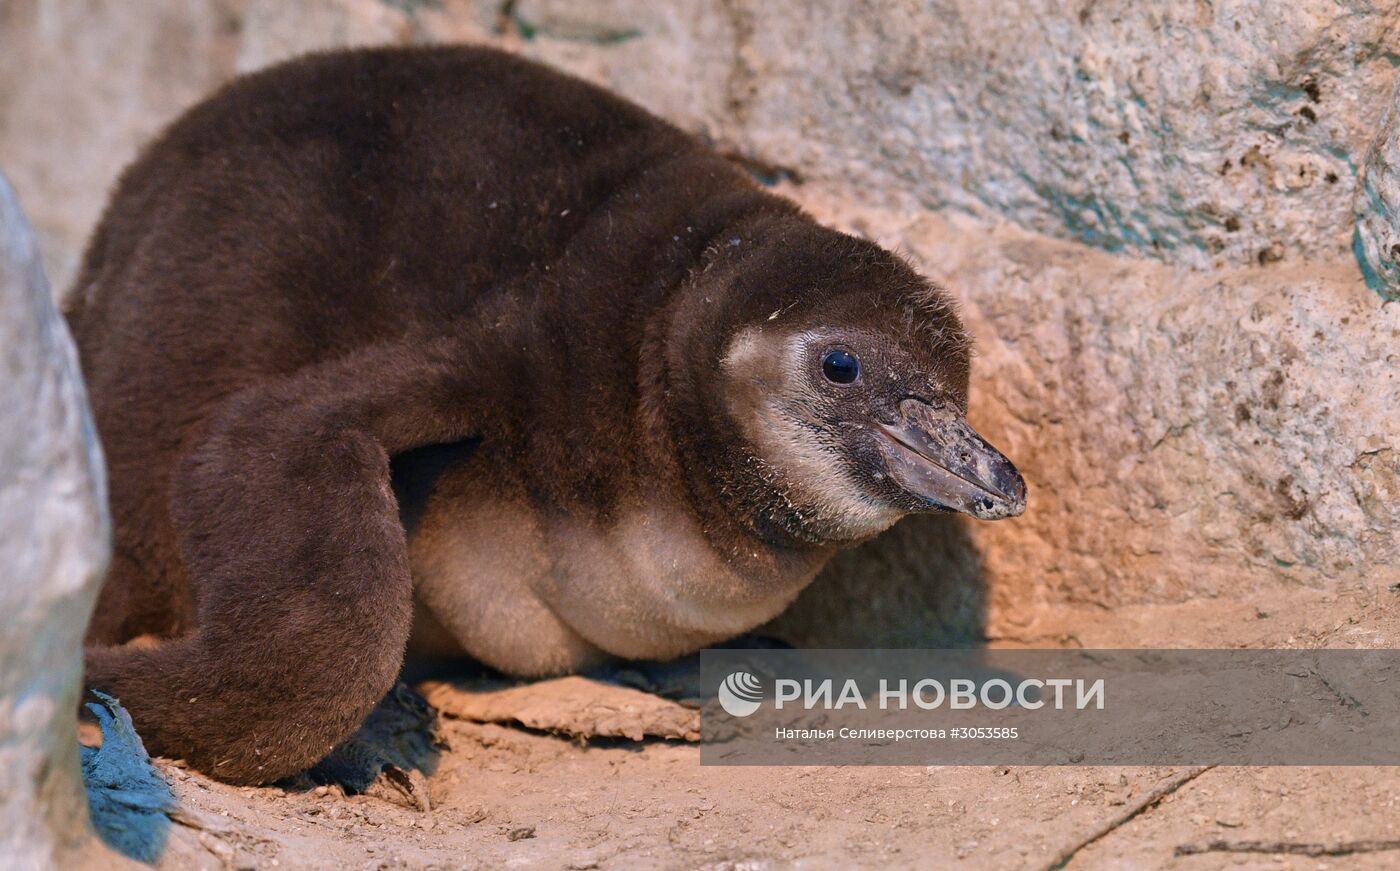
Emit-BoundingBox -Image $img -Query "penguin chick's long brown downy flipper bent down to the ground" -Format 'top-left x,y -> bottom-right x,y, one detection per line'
87,336 -> 490,783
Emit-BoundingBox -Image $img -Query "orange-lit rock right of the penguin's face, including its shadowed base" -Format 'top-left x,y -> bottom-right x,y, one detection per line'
780,196 -> 1400,644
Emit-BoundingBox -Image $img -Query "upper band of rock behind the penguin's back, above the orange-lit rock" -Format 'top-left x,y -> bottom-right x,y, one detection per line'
10,0 -> 1400,287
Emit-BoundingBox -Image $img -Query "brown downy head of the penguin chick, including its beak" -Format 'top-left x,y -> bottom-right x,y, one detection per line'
677,221 -> 1026,543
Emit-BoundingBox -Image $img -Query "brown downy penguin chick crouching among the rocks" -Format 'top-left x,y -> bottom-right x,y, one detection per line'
69,48 -> 1025,783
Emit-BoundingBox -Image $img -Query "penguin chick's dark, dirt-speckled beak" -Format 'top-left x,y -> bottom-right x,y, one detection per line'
879,399 -> 1026,520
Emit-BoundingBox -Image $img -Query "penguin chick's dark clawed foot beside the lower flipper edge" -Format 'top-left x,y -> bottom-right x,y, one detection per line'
284,683 -> 445,811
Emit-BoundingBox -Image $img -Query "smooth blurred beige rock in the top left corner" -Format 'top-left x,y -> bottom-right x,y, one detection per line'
0,0 -> 241,293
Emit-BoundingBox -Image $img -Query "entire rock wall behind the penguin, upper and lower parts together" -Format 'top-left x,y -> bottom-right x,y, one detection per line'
0,0 -> 1400,643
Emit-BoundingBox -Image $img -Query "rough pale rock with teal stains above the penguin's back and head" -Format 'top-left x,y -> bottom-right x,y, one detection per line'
490,0 -> 1400,266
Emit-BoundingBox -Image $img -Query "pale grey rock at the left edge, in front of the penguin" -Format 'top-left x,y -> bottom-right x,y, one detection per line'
0,176 -> 111,868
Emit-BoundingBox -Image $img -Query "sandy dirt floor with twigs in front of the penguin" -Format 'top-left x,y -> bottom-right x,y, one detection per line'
133,590 -> 1400,871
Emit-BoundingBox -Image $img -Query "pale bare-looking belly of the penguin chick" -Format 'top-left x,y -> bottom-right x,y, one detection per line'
409,503 -> 816,676
